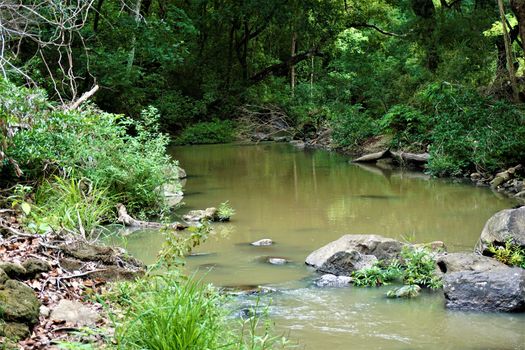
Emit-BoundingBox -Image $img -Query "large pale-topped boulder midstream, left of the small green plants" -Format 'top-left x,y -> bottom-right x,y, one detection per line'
305,235 -> 403,276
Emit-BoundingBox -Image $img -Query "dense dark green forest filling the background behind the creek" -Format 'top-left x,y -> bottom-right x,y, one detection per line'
0,0 -> 525,175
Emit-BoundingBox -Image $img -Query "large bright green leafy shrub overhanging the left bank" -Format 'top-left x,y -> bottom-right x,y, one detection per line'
0,82 -> 177,213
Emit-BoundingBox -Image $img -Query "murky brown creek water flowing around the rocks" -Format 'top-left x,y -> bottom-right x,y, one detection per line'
121,144 -> 525,350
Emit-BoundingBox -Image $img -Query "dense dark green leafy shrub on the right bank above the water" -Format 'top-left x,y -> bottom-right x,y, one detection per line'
417,83 -> 525,176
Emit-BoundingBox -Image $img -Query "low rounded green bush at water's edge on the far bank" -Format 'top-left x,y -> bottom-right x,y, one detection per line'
175,119 -> 235,145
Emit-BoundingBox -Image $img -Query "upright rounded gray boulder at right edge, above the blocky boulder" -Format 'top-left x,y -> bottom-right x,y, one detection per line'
476,207 -> 525,255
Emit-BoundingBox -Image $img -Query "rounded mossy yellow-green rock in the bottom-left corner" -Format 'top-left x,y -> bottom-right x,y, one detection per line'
0,280 -> 40,324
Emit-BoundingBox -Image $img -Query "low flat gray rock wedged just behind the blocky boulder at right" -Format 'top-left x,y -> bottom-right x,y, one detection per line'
436,253 -> 507,273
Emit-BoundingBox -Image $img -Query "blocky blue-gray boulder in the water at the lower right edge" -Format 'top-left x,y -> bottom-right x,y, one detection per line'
443,267 -> 525,312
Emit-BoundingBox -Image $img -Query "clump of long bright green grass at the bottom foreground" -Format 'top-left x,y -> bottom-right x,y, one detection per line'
116,274 -> 228,350
